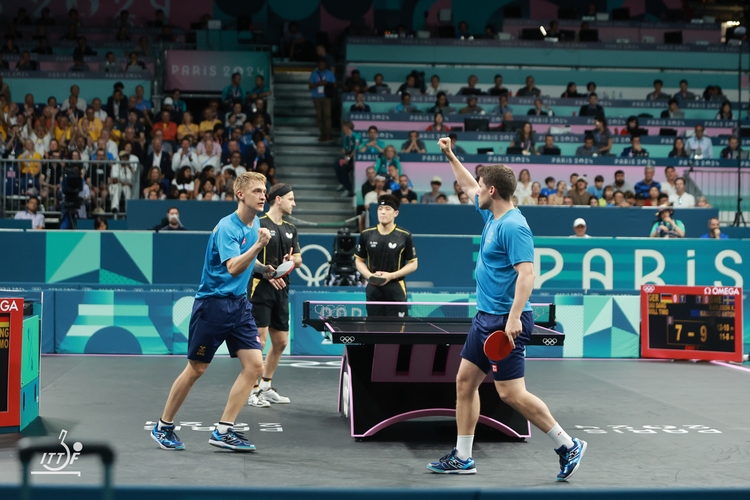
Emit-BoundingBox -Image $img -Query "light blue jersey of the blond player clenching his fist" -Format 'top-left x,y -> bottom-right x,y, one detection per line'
195,212 -> 260,299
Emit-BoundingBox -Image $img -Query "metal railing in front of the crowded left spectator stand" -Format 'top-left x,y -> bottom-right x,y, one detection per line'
0,158 -> 143,217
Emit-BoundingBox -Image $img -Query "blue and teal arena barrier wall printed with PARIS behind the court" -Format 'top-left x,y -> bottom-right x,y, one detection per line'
0,231 -> 750,357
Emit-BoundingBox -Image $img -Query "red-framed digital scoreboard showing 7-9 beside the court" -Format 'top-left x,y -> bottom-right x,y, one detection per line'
641,285 -> 742,362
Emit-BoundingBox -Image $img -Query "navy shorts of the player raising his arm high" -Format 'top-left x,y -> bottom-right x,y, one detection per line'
461,311 -> 534,380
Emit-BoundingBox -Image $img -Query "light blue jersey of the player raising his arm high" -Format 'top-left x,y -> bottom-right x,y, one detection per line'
474,195 -> 534,315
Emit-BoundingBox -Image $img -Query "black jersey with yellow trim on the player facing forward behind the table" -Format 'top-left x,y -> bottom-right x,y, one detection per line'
354,225 -> 417,279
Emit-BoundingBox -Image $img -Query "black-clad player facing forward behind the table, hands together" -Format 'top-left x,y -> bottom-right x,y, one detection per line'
354,194 -> 417,317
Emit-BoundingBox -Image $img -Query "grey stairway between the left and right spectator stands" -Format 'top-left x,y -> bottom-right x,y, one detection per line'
273,66 -> 355,233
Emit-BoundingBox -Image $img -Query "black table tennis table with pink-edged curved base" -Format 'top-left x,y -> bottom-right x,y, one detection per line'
303,301 -> 565,439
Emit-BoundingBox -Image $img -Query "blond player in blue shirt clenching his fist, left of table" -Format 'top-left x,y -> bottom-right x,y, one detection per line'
151,172 -> 283,451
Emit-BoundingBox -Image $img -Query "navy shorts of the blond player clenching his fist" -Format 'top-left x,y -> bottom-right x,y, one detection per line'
188,297 -> 260,363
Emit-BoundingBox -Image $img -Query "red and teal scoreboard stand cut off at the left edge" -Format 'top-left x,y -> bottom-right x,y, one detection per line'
0,298 -> 39,433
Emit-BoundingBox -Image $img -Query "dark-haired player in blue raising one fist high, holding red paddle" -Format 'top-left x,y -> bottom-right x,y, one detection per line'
427,138 -> 586,481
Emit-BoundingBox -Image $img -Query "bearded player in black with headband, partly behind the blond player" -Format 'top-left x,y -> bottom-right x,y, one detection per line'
247,184 -> 302,408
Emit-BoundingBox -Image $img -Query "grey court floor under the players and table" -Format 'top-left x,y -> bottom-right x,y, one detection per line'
0,356 -> 750,489
